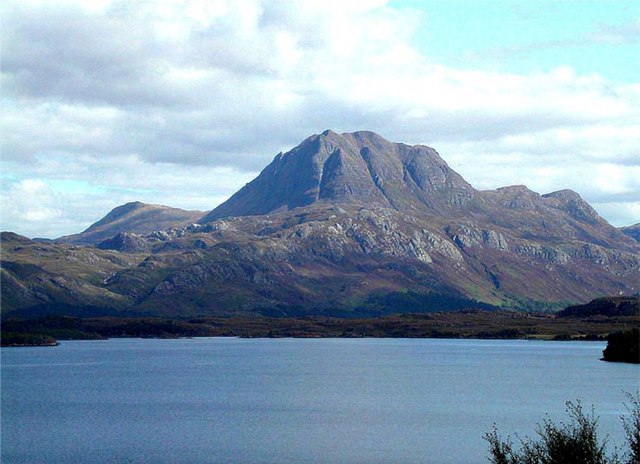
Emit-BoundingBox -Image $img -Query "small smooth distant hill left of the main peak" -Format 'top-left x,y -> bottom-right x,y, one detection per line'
56,201 -> 203,245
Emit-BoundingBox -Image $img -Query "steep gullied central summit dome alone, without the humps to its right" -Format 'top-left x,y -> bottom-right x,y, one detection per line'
200,130 -> 475,222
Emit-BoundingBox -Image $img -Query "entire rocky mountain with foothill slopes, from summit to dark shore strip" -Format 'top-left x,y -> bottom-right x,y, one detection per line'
2,131 -> 640,316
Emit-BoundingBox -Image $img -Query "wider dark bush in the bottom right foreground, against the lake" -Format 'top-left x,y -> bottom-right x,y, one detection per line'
484,401 -> 620,464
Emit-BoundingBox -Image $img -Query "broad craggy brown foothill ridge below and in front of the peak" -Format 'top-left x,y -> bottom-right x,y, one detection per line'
1,206 -> 639,317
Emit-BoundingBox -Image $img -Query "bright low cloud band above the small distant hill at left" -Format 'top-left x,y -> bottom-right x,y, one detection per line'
0,155 -> 255,238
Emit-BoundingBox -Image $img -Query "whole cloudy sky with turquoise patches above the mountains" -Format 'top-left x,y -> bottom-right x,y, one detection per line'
0,0 -> 640,238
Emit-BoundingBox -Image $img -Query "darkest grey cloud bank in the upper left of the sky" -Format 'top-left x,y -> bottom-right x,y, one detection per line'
2,7 -> 255,108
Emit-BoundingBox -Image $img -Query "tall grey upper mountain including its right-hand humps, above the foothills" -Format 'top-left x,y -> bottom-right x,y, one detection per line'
199,131 -> 630,249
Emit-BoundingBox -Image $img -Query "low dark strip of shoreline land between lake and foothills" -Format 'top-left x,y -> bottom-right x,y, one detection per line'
0,308 -> 638,344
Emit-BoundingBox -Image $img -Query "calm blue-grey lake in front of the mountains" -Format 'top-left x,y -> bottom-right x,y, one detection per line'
1,338 -> 640,464
